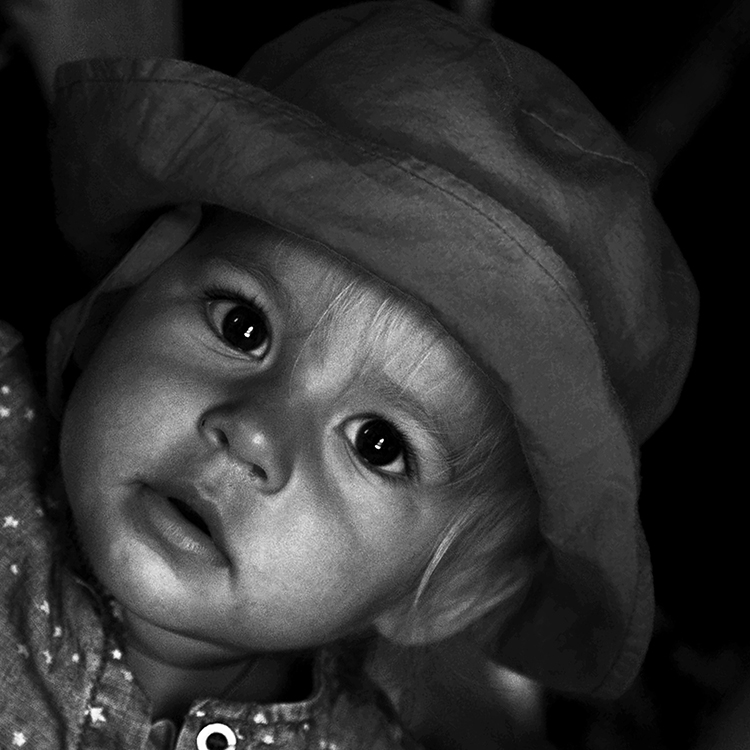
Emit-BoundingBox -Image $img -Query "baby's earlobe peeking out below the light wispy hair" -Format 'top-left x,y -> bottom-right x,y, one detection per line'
374,597 -> 483,646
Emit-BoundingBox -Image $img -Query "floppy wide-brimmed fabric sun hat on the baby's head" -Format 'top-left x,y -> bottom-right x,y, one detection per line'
50,0 -> 697,697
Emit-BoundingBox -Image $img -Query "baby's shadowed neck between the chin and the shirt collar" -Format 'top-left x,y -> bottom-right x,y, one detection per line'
126,618 -> 307,723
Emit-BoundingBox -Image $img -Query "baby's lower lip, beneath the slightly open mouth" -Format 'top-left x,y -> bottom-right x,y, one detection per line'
135,485 -> 228,567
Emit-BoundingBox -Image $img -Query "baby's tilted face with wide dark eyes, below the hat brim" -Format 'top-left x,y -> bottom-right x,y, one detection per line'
62,213 -> 506,650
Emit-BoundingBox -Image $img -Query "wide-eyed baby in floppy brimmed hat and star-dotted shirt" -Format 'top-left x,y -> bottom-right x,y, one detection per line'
0,0 -> 696,750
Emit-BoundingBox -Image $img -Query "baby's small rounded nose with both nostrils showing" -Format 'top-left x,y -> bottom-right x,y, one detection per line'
199,403 -> 295,493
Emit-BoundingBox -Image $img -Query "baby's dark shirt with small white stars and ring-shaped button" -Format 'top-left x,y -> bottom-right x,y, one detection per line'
0,322 -> 417,750
